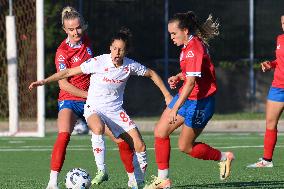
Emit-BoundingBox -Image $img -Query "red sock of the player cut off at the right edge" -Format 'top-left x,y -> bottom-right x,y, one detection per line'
263,129 -> 278,160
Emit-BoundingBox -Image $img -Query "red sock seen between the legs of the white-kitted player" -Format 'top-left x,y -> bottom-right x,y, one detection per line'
117,141 -> 134,173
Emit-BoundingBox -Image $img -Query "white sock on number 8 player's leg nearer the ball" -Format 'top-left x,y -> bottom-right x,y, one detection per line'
91,133 -> 106,172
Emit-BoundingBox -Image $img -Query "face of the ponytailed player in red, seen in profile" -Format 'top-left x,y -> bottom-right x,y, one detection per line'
168,21 -> 188,46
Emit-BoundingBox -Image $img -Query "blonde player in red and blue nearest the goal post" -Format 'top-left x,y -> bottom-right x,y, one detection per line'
44,7 -> 139,189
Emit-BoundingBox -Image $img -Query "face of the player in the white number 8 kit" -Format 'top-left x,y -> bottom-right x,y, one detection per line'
110,39 -> 126,65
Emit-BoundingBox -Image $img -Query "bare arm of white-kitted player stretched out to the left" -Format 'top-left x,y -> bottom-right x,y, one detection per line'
29,66 -> 83,90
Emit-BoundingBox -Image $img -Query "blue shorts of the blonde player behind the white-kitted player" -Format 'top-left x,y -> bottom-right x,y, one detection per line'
58,100 -> 85,120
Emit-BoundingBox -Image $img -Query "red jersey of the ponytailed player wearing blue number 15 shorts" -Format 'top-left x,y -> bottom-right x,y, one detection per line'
179,35 -> 217,100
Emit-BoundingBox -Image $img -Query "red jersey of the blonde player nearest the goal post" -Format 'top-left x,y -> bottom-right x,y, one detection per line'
55,36 -> 93,101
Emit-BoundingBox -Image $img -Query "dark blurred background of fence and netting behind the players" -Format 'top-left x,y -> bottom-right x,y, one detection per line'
0,0 -> 284,118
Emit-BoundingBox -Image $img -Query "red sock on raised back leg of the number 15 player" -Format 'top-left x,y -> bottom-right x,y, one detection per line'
189,142 -> 221,161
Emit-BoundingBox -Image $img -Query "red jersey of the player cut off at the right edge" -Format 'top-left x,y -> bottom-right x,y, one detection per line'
270,34 -> 284,88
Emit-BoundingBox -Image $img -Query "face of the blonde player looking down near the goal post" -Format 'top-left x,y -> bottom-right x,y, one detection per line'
63,18 -> 83,44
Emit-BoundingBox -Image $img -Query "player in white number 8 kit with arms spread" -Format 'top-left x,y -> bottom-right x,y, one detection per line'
29,29 -> 172,188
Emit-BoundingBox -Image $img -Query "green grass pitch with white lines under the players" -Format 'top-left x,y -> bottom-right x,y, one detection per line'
0,133 -> 284,189
